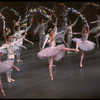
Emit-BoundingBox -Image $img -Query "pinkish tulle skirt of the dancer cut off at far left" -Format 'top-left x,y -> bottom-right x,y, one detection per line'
0,60 -> 14,73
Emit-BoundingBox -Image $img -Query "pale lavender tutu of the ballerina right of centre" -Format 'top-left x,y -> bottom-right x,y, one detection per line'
72,38 -> 95,51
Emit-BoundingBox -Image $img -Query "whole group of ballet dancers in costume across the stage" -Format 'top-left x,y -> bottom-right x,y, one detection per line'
0,2 -> 100,96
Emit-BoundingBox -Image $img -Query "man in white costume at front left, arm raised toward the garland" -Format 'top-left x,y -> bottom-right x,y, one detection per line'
0,32 -> 27,82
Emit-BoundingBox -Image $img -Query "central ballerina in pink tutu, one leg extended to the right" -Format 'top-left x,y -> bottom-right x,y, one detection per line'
37,22 -> 79,81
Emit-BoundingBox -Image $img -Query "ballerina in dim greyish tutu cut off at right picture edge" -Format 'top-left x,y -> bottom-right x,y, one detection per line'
90,15 -> 100,48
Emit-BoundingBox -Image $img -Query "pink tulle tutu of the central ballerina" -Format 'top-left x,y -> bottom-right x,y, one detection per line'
37,44 -> 65,61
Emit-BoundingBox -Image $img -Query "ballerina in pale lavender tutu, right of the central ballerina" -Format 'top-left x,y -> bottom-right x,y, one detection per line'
72,20 -> 95,67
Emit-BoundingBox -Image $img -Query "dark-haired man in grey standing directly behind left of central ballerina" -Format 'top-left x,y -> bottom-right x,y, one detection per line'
34,19 -> 49,50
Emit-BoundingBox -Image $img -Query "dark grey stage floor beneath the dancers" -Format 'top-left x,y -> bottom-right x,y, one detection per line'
0,43 -> 100,99
